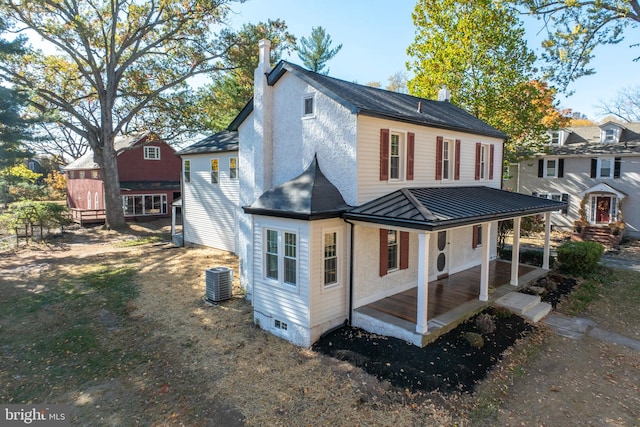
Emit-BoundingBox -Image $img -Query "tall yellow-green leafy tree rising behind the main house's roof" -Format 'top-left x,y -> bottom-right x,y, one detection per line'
407,0 -> 563,161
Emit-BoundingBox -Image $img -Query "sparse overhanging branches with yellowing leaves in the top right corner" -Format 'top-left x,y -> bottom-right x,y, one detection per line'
514,0 -> 640,91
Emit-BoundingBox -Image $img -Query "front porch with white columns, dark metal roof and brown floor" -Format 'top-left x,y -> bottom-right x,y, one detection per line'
344,187 -> 566,346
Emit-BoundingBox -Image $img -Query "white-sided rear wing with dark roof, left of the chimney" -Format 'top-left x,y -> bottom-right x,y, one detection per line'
177,131 -> 240,253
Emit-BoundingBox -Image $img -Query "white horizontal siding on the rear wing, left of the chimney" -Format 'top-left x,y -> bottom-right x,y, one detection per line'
182,152 -> 239,253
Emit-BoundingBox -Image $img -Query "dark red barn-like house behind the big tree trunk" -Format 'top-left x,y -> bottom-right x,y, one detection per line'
65,133 -> 181,223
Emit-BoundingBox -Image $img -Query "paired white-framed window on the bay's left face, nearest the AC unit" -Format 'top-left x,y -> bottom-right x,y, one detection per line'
264,229 -> 298,286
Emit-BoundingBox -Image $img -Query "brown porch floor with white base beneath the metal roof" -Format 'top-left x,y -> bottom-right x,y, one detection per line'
352,260 -> 548,346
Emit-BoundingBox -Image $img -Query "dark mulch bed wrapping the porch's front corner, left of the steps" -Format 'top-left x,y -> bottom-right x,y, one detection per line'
313,308 -> 534,393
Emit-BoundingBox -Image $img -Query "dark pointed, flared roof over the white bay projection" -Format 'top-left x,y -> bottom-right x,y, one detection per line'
243,158 -> 349,220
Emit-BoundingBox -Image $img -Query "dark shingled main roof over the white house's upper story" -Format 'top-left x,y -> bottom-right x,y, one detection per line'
229,61 -> 507,139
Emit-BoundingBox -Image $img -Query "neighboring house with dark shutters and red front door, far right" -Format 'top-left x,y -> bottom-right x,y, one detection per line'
505,122 -> 640,241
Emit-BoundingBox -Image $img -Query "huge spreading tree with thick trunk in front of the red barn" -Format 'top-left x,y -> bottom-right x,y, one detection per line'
0,0 -> 238,229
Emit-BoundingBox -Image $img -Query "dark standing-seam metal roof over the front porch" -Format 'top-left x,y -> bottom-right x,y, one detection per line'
343,186 -> 567,231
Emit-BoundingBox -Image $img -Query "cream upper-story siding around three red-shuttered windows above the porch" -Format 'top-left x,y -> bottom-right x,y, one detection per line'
357,116 -> 502,204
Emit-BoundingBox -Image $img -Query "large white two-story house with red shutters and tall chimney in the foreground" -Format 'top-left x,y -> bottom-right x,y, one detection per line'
183,40 -> 564,347
